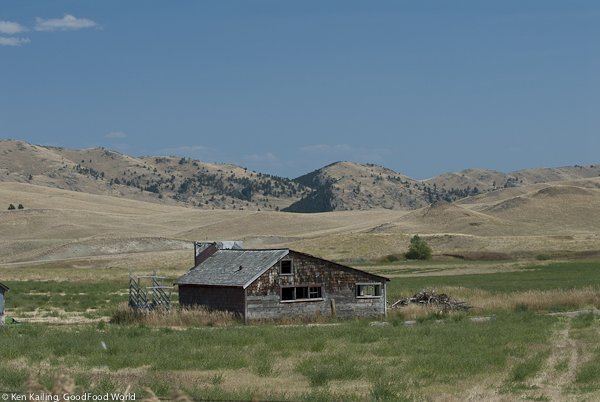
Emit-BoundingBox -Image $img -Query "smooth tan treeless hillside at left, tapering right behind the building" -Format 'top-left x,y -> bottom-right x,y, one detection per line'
0,183 -> 404,263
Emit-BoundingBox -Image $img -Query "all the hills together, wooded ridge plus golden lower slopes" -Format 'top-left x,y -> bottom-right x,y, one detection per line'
0,140 -> 600,267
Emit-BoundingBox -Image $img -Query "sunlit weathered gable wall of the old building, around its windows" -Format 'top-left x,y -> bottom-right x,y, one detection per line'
246,251 -> 385,320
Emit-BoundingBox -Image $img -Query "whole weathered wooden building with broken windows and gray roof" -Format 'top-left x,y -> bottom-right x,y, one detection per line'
174,241 -> 389,323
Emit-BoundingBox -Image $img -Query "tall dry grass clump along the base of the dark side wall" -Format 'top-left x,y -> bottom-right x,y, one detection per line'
110,303 -> 240,327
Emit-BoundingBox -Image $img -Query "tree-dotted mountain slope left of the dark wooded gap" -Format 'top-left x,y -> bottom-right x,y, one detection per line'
0,140 -> 309,211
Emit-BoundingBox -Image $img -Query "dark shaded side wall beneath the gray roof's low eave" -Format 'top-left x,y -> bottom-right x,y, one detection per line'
179,285 -> 245,316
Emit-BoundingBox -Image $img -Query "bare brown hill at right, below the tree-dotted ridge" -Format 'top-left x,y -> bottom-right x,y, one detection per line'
360,178 -> 600,240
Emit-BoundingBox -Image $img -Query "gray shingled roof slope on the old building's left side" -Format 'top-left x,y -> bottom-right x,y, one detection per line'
174,248 -> 290,288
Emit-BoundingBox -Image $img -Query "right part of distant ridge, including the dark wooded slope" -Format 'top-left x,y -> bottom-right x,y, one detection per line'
284,162 -> 600,212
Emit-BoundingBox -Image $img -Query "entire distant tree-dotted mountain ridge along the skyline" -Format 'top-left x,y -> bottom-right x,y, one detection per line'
0,140 -> 600,213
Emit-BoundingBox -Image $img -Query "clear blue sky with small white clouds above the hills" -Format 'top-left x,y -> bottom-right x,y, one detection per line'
0,0 -> 600,179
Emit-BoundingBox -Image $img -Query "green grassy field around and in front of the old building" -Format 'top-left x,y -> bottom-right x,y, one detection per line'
0,260 -> 600,401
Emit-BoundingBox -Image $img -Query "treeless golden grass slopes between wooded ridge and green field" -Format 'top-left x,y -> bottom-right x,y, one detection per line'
0,174 -> 600,262
